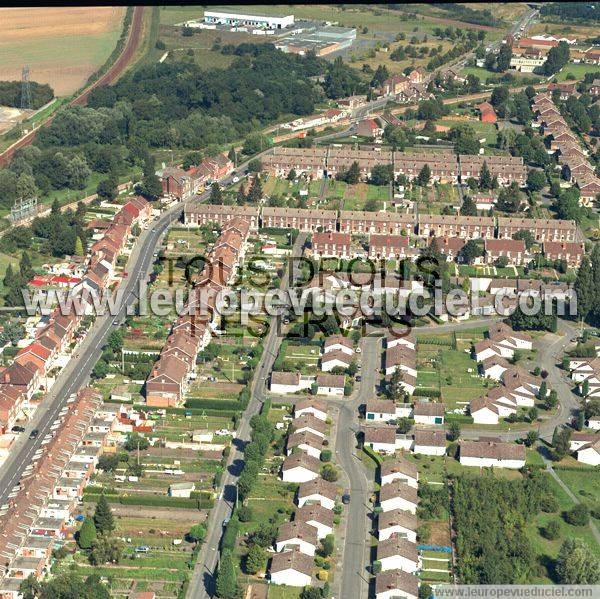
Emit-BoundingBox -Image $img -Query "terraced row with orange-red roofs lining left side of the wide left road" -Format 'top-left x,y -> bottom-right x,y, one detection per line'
0,197 -> 151,440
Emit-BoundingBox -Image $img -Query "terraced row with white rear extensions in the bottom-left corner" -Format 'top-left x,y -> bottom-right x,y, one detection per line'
0,388 -> 119,599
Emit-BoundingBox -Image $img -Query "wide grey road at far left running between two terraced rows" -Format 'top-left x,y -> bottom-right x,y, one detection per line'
0,197 -> 181,504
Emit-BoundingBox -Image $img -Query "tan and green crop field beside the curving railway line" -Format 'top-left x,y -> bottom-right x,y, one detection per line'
0,6 -> 125,96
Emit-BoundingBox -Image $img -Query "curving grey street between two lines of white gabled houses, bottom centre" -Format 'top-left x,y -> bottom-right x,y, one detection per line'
336,337 -> 381,599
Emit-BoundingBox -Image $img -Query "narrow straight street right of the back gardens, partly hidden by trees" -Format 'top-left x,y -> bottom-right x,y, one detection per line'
187,233 -> 307,599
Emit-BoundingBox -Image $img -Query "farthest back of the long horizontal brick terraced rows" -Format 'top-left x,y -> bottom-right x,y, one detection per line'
261,146 -> 526,186
